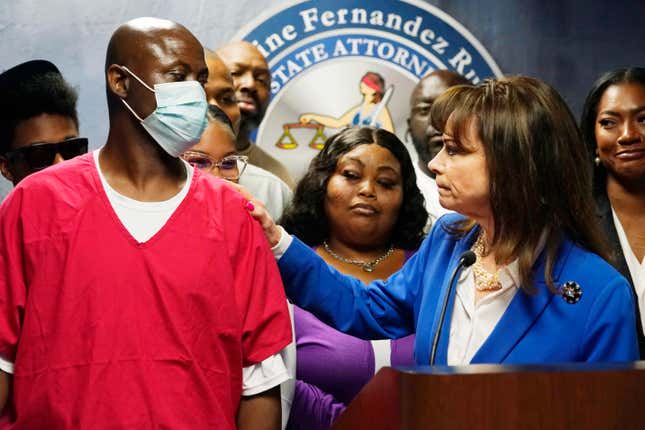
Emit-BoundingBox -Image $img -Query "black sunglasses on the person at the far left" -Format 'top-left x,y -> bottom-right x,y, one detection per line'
5,137 -> 88,171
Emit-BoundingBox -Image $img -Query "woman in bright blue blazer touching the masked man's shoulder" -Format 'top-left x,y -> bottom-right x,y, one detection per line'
252,76 -> 638,365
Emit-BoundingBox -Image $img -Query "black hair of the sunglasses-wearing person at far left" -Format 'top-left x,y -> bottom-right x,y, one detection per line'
0,60 -> 78,154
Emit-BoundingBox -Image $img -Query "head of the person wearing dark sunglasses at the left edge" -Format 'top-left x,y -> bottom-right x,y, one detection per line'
0,60 -> 87,185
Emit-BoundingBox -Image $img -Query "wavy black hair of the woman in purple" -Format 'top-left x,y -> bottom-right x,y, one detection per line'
280,127 -> 428,249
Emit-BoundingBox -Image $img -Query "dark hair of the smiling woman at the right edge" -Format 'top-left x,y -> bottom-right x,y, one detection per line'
580,67 -> 645,192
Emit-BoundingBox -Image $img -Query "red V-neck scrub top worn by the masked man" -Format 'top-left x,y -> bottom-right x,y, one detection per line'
0,154 -> 291,430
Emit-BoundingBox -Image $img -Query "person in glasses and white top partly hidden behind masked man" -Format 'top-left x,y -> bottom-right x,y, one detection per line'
181,105 -> 292,219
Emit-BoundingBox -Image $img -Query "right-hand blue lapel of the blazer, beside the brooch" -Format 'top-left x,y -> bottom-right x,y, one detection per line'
471,241 -> 572,364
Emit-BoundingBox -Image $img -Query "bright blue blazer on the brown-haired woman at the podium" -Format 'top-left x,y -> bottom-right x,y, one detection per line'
278,214 -> 638,364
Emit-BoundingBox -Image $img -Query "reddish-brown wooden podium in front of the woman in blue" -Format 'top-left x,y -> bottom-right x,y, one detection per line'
333,361 -> 645,430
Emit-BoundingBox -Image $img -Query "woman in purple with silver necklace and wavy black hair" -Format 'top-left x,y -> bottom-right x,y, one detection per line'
281,127 -> 427,430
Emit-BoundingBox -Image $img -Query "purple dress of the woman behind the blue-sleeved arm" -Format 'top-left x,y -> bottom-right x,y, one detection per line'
287,251 -> 415,430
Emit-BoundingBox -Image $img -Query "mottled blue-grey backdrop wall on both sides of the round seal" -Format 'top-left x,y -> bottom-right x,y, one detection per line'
0,0 -> 645,199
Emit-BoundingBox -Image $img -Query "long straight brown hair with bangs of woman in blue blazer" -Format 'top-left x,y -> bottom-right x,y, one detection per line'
430,76 -> 606,291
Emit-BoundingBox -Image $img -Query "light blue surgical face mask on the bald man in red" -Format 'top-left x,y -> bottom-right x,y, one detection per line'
121,66 -> 208,157
